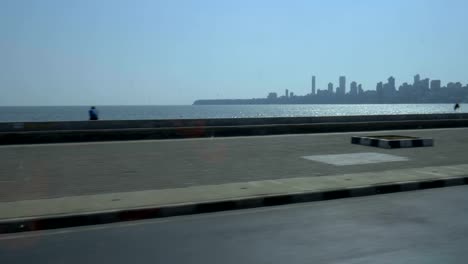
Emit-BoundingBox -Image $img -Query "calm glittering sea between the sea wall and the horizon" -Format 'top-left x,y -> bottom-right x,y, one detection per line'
0,104 -> 468,122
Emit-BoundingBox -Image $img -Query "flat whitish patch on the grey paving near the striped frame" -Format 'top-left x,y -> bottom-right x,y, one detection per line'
302,152 -> 409,166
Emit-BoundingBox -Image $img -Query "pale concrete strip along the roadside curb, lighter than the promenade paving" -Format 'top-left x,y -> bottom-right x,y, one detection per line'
0,164 -> 468,221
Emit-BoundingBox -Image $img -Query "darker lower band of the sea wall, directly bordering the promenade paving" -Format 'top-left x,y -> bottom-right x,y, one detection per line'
0,119 -> 468,145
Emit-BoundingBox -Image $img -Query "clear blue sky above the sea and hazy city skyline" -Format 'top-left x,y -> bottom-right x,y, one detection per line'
0,0 -> 468,105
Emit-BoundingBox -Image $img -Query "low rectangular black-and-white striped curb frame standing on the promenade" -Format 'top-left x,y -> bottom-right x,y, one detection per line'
351,136 -> 434,149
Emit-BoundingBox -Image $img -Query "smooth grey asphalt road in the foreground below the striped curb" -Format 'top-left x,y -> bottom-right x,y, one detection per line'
0,186 -> 468,264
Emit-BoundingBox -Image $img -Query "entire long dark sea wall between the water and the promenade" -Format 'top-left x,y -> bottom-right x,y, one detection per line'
0,114 -> 468,145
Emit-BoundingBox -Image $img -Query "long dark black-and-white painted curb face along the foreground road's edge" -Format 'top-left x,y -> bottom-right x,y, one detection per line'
0,176 -> 468,234
